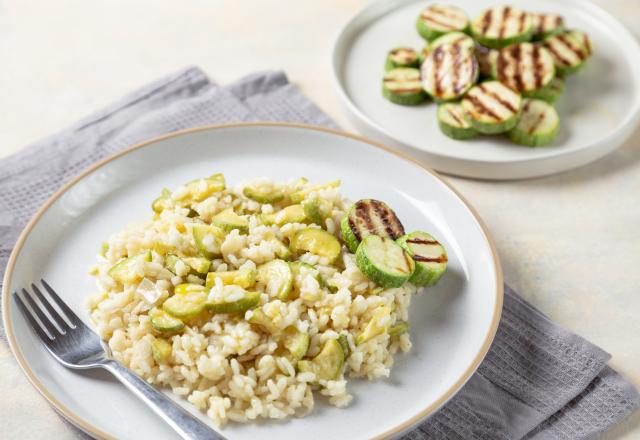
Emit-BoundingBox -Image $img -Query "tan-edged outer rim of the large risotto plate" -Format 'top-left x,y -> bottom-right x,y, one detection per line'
1,122 -> 504,440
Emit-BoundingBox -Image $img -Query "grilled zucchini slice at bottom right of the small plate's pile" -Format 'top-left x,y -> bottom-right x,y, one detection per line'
507,99 -> 560,147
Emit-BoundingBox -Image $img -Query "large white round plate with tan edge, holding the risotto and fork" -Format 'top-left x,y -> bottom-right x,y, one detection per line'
3,124 -> 502,440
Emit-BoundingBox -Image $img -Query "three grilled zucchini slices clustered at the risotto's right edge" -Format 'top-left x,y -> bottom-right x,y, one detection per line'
340,199 -> 448,288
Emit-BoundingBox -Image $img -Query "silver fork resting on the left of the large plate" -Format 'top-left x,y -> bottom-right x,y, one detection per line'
13,280 -> 224,440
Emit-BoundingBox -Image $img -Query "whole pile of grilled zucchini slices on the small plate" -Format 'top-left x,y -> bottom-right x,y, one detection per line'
382,5 -> 593,147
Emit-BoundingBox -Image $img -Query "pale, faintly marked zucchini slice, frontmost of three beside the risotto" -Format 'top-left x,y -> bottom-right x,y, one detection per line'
356,235 -> 415,288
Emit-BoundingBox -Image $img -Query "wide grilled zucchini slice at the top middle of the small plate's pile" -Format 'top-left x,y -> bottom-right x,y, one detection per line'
471,6 -> 533,49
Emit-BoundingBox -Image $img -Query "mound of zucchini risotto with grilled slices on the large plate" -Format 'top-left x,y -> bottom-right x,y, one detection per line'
88,174 -> 447,426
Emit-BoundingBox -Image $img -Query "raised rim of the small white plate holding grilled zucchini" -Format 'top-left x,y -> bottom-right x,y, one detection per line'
330,0 -> 640,180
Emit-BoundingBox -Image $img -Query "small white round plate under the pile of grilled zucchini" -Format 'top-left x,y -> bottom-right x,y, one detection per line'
332,0 -> 640,179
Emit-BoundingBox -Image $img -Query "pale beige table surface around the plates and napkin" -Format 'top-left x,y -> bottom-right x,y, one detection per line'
0,0 -> 640,439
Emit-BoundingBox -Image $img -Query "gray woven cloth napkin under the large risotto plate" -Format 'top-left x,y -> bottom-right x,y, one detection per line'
0,68 -> 640,440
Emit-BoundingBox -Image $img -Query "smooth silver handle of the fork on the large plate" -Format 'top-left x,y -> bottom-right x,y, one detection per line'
103,360 -> 224,440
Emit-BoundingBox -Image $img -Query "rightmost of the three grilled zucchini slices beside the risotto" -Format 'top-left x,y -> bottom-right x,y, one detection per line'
398,231 -> 448,287
